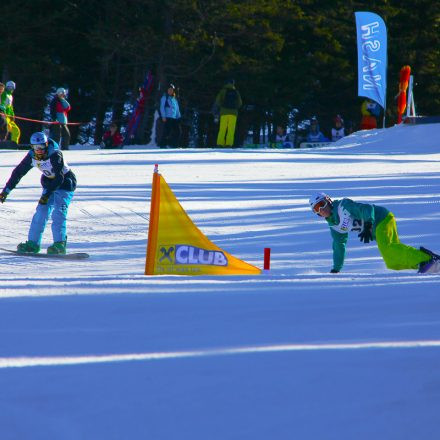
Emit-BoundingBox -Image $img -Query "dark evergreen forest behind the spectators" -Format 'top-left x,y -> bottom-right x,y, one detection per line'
0,0 -> 440,147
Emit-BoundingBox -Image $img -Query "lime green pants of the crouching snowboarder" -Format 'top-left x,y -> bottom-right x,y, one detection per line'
376,212 -> 431,270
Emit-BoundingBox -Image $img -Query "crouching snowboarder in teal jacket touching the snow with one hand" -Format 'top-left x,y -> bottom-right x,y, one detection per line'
309,192 -> 440,273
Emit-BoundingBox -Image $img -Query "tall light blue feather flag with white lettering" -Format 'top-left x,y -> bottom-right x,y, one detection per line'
355,12 -> 387,109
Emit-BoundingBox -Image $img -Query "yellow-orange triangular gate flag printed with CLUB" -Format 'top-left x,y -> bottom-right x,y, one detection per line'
145,165 -> 261,275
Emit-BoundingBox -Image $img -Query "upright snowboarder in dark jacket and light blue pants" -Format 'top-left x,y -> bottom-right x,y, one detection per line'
0,132 -> 76,254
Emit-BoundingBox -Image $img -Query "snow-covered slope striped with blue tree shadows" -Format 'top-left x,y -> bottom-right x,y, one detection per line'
0,125 -> 440,440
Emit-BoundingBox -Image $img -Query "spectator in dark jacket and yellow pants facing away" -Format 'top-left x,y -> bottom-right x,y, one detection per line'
215,79 -> 243,147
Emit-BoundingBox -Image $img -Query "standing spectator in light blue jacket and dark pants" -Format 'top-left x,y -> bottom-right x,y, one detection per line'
159,84 -> 181,148
